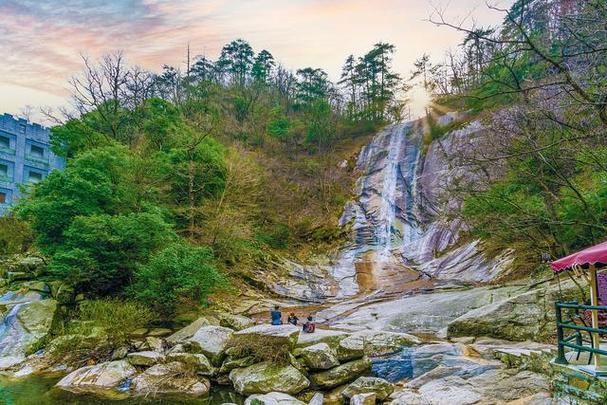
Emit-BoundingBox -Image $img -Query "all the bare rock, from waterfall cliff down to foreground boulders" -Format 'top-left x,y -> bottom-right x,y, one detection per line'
0,116 -> 578,405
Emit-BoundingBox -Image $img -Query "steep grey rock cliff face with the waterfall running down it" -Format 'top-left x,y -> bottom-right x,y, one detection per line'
274,113 -> 510,300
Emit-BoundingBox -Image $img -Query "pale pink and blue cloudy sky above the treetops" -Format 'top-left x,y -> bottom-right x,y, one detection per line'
0,0 -> 512,120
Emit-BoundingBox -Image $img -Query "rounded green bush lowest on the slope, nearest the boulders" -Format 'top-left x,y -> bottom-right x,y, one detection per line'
130,243 -> 226,316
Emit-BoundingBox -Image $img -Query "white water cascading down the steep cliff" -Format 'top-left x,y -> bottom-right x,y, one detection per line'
331,123 -> 420,297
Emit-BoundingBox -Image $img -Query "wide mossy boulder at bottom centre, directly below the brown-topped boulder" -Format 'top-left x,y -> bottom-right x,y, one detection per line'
230,362 -> 310,395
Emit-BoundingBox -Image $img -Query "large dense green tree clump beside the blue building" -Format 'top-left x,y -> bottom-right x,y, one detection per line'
15,146 -> 175,294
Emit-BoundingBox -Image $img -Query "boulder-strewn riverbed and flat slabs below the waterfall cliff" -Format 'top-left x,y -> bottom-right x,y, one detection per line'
4,274 -> 576,405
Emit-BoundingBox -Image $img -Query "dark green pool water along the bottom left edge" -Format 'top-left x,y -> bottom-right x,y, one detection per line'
0,377 -> 244,405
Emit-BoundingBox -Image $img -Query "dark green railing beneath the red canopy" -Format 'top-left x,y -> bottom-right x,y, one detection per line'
554,301 -> 607,364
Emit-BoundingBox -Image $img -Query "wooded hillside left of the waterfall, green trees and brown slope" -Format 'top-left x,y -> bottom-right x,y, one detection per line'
7,39 -> 403,317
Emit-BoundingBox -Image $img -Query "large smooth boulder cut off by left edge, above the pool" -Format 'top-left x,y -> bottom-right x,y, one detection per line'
0,292 -> 57,370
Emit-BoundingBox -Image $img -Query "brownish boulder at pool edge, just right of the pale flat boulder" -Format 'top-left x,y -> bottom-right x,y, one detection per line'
131,362 -> 211,396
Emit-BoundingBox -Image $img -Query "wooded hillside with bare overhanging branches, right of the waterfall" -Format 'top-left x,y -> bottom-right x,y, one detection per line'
415,0 -> 607,270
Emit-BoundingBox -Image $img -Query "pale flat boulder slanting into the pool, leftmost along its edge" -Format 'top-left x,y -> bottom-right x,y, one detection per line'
57,360 -> 137,394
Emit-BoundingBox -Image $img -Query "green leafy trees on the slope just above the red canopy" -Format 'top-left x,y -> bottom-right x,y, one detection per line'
463,143 -> 607,268
